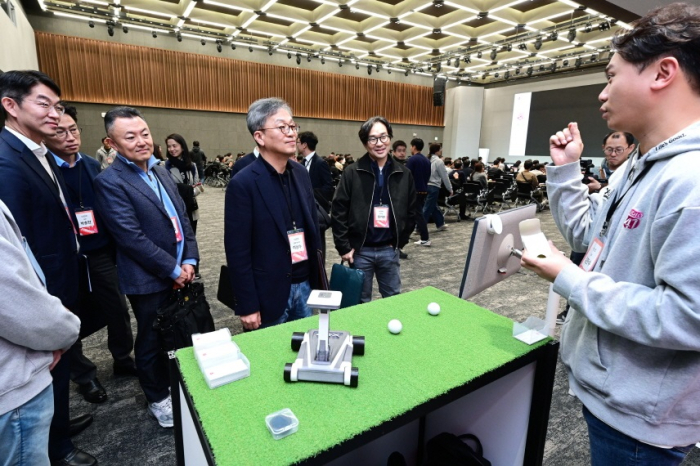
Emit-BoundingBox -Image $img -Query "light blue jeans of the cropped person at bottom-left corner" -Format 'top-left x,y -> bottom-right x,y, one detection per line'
0,384 -> 53,466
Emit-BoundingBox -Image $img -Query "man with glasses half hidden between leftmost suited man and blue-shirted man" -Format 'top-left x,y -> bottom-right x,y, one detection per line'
46,104 -> 136,403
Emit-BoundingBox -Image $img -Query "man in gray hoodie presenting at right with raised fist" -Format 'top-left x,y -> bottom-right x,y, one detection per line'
523,3 -> 700,466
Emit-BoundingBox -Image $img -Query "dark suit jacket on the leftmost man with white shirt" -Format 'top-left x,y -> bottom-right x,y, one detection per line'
0,129 -> 78,309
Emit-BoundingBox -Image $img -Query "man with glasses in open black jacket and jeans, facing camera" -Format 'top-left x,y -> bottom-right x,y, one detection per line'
331,116 -> 417,303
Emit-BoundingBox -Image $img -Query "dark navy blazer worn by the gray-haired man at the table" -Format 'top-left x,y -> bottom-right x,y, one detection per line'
224,155 -> 319,322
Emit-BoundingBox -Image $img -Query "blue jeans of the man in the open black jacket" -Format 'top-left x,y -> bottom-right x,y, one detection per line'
352,246 -> 401,303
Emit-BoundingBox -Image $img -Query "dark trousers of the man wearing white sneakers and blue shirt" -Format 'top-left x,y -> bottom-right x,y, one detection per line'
128,289 -> 170,403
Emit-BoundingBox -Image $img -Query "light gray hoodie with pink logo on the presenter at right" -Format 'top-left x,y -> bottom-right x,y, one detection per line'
547,122 -> 700,446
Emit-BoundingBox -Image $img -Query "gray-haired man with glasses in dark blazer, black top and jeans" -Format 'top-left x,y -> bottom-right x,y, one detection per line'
224,98 -> 321,331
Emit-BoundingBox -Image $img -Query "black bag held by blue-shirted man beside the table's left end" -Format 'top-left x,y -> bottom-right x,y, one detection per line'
153,282 -> 215,352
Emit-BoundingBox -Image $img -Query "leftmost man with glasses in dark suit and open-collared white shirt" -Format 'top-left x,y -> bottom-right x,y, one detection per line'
0,71 -> 97,465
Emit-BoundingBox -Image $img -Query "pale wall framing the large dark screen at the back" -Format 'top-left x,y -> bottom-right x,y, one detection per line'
480,72 -> 605,166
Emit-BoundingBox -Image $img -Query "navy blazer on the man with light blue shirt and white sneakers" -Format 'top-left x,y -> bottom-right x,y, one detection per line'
95,157 -> 199,294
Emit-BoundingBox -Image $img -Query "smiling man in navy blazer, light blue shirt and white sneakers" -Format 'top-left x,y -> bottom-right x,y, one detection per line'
95,107 -> 199,427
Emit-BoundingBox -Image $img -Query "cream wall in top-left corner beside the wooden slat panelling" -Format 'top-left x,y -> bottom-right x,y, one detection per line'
0,0 -> 39,71
